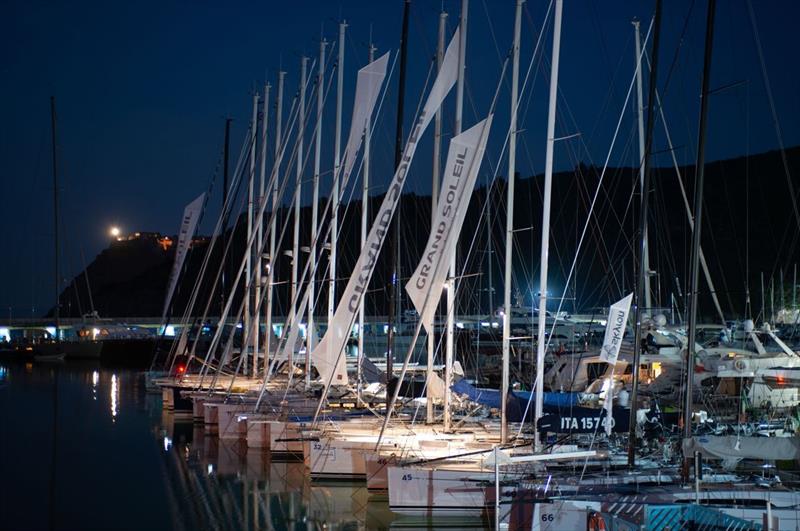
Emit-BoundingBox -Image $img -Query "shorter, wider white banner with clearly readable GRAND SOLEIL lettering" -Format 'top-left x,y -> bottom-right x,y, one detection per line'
406,114 -> 492,334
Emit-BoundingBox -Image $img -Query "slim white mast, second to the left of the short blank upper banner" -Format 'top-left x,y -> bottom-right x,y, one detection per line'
306,38 -> 328,384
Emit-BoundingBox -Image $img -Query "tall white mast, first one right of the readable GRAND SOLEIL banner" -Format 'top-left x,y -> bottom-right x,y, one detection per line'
500,0 -> 525,444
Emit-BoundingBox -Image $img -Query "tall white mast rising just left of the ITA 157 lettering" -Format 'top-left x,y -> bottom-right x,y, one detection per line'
534,0 -> 563,451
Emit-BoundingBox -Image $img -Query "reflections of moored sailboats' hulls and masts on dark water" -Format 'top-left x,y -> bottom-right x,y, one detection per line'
160,412 -> 393,530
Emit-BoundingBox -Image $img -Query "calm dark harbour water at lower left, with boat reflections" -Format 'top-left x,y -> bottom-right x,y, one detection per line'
0,360 -> 410,531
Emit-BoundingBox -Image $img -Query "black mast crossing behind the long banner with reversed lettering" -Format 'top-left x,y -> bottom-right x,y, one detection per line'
386,0 -> 411,411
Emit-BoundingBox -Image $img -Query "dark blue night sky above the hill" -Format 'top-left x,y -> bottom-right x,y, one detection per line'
0,0 -> 800,317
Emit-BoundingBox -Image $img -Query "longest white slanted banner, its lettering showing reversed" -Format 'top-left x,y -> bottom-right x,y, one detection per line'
311,30 -> 460,386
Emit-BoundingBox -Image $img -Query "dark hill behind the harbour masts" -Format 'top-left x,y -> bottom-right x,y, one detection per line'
56,147 -> 800,318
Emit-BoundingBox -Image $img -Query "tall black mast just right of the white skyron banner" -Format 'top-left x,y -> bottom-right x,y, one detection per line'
628,0 -> 661,467
